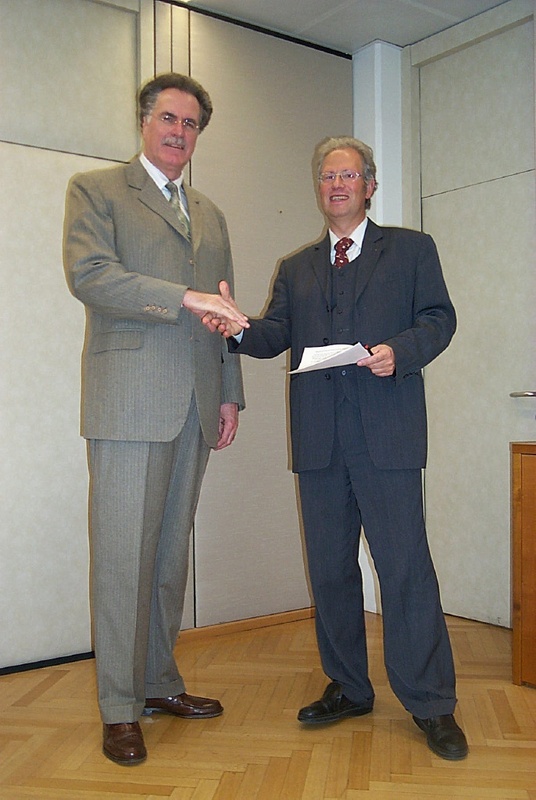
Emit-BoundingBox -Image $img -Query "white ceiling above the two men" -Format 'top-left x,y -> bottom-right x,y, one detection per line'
185,0 -> 505,53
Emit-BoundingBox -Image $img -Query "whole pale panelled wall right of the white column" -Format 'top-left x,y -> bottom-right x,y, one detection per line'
411,0 -> 536,626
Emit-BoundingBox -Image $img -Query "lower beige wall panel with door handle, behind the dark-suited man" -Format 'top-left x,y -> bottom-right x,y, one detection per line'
423,172 -> 536,625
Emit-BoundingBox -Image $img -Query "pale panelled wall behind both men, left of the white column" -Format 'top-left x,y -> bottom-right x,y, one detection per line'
0,0 -> 352,668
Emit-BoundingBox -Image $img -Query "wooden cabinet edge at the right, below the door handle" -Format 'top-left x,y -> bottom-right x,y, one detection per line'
510,442 -> 536,686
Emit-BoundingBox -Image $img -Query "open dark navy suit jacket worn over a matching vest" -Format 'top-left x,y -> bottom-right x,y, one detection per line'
230,220 -> 456,472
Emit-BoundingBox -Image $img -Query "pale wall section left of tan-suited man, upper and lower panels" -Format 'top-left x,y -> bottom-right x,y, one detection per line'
0,0 -> 146,666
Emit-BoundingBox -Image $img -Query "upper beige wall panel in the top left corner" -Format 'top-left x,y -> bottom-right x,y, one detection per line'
0,0 -> 138,160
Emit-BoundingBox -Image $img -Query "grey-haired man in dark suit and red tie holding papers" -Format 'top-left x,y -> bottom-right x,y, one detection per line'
204,137 -> 468,760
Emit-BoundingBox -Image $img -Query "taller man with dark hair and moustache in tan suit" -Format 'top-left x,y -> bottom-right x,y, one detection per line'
64,73 -> 247,765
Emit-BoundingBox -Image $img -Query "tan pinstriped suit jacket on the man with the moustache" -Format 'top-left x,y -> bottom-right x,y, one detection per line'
64,158 -> 244,447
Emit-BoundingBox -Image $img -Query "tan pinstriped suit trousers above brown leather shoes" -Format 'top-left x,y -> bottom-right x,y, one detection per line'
89,399 -> 209,724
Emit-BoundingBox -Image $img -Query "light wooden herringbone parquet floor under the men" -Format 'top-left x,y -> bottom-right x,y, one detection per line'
0,614 -> 536,800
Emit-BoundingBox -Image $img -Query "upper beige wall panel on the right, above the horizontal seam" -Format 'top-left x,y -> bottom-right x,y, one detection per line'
421,21 -> 534,197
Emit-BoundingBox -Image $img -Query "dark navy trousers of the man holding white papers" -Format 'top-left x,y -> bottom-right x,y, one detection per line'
299,400 -> 456,719
